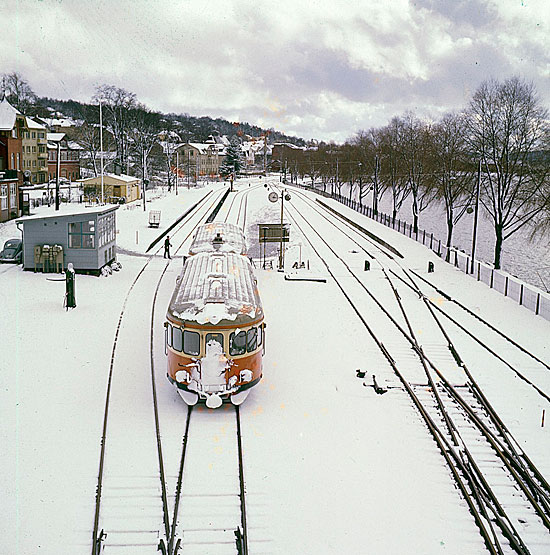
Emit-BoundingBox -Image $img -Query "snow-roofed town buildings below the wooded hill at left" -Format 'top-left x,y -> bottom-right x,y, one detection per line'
0,95 -> 303,221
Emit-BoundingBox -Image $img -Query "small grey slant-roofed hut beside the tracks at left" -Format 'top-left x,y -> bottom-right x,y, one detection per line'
16,206 -> 118,274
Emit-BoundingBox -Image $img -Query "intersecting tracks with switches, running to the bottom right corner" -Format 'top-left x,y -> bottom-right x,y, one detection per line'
289,191 -> 550,553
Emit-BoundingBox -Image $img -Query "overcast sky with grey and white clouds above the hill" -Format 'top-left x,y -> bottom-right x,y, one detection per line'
0,0 -> 550,142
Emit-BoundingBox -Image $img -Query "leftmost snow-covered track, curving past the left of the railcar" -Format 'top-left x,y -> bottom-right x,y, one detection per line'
91,190 -> 229,555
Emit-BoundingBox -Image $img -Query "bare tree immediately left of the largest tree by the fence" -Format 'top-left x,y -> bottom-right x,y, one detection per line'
431,114 -> 475,252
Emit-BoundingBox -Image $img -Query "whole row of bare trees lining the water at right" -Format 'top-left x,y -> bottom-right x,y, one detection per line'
283,77 -> 550,268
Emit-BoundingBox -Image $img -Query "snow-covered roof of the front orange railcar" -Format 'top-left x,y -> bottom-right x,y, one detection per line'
168,252 -> 263,324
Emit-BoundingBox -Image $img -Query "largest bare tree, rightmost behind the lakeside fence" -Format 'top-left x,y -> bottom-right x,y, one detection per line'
468,77 -> 550,268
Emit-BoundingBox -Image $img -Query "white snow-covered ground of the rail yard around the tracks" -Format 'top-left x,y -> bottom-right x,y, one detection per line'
0,178 -> 550,555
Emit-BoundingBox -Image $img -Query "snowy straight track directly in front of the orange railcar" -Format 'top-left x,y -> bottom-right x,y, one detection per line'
161,404 -> 248,554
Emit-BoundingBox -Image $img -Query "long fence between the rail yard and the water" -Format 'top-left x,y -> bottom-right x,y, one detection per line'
295,185 -> 550,321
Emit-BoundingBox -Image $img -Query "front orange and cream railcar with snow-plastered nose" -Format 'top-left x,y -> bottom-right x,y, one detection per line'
165,226 -> 265,408
